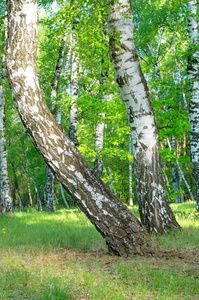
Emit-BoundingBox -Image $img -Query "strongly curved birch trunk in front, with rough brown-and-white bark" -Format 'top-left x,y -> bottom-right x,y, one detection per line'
6,0 -> 154,256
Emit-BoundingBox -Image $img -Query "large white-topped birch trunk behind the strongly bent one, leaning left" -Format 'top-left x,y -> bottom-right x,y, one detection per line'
109,0 -> 179,233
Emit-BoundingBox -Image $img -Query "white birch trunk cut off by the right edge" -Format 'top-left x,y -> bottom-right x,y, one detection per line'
188,0 -> 199,211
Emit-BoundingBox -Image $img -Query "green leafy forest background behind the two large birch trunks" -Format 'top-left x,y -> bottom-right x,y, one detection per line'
0,0 -> 198,209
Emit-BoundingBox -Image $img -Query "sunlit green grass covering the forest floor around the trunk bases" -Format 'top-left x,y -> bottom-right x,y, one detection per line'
0,203 -> 199,300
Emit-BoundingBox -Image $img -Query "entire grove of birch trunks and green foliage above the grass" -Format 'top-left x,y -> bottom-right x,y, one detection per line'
0,0 -> 199,256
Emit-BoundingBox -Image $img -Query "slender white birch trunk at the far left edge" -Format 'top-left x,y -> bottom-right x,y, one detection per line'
0,18 -> 13,212
